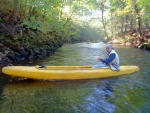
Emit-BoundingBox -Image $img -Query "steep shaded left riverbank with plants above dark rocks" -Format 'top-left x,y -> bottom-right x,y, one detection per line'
0,10 -> 63,67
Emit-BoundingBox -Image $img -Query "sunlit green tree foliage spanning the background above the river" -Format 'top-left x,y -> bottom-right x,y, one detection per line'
0,0 -> 150,43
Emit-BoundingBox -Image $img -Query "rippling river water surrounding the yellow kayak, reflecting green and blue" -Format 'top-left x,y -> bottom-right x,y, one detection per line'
0,43 -> 150,113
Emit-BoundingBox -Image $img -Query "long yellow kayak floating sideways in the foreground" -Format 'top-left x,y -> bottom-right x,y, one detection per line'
2,66 -> 139,80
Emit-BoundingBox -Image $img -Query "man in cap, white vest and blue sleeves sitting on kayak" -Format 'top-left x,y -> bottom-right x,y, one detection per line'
93,45 -> 120,71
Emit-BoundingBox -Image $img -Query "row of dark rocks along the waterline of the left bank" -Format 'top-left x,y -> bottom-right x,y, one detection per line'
0,41 -> 62,67
